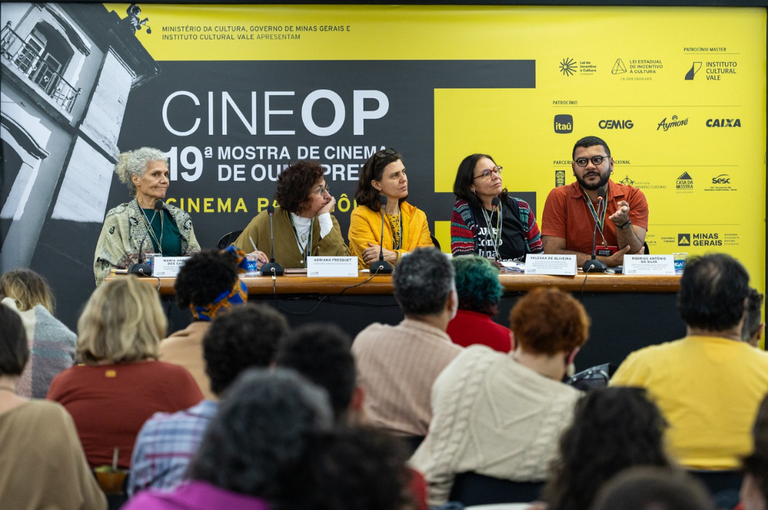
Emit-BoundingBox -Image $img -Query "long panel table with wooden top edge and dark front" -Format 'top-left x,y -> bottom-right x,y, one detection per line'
120,272 -> 685,370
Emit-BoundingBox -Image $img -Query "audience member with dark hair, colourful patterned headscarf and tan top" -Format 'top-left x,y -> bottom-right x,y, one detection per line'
160,247 -> 248,400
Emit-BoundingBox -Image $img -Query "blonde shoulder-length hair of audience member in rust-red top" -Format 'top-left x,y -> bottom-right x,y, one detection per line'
77,275 -> 168,365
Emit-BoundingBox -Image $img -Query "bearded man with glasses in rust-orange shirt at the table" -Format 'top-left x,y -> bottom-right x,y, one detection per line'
541,136 -> 648,267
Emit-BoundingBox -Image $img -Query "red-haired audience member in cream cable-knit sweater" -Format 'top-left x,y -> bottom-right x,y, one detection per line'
411,288 -> 589,506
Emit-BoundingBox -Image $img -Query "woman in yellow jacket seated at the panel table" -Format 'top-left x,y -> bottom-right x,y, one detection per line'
349,149 -> 432,269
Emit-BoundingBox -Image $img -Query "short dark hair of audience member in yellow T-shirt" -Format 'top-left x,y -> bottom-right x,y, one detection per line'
677,253 -> 749,331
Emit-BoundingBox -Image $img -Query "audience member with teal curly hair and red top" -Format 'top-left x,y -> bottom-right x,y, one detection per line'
447,255 -> 512,352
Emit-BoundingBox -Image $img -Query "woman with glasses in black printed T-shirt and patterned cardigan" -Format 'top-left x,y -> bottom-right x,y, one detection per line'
451,154 -> 543,261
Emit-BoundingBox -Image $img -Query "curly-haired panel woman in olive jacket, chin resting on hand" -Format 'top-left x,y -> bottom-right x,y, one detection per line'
233,161 -> 349,267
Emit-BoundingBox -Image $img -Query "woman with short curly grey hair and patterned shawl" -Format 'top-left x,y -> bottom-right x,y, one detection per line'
93,147 -> 200,285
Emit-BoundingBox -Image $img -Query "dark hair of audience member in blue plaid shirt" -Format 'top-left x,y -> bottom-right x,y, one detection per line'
203,304 -> 288,396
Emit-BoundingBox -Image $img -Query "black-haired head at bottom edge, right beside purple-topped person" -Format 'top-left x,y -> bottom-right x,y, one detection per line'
292,426 -> 413,510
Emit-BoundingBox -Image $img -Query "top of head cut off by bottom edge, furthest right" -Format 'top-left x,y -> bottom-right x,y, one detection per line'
592,466 -> 715,510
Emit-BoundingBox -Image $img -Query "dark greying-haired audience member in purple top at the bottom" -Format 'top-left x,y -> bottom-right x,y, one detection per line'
123,368 -> 333,510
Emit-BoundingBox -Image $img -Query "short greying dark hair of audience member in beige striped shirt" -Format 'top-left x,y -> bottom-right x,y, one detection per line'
392,248 -> 454,315
